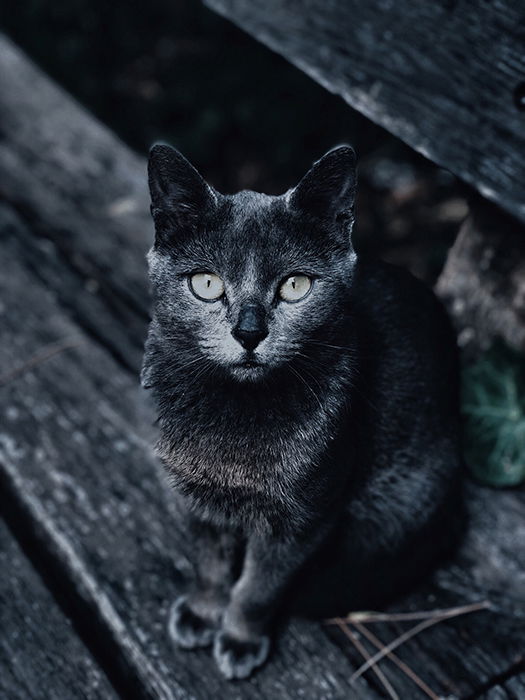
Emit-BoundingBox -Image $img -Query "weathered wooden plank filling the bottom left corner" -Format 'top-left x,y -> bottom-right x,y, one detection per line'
0,519 -> 117,700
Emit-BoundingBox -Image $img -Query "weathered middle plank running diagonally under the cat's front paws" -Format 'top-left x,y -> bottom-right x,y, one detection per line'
0,209 -> 377,700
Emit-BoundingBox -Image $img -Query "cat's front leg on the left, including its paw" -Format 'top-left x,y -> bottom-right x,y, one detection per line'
169,517 -> 241,649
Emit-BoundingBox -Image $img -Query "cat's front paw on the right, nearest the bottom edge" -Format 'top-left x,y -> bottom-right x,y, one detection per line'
213,632 -> 270,680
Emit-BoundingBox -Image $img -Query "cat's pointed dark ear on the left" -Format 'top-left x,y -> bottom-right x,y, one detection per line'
148,145 -> 216,243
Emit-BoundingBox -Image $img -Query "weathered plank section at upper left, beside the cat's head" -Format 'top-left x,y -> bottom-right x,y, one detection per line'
0,33 -> 153,367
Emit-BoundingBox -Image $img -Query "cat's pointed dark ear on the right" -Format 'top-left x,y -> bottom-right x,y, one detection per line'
288,146 -> 357,226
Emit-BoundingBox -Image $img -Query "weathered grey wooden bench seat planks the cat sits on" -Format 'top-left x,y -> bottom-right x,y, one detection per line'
0,31 -> 525,700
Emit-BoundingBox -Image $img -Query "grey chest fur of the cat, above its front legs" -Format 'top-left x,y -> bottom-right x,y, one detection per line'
152,372 -> 348,528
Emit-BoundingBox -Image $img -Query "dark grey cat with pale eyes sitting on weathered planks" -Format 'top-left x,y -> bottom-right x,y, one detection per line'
142,145 -> 462,679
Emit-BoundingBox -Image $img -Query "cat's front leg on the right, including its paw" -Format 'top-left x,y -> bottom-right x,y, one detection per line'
213,535 -> 316,679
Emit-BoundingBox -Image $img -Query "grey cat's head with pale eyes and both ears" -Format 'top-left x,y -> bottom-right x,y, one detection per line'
148,146 -> 356,381
